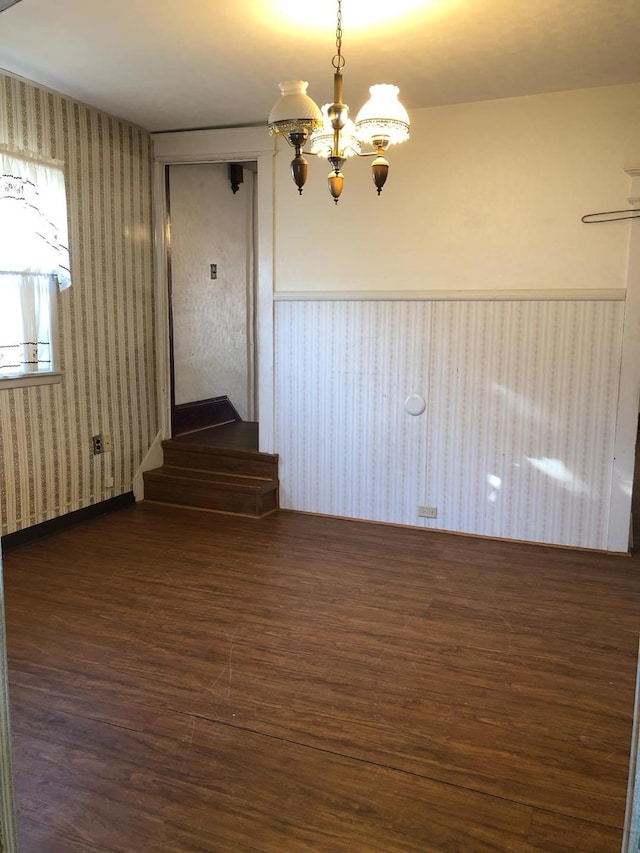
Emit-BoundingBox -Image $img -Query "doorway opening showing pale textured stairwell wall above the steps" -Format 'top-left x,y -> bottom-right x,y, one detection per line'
165,161 -> 257,437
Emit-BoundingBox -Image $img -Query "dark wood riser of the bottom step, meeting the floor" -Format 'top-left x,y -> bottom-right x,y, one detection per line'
144,480 -> 278,518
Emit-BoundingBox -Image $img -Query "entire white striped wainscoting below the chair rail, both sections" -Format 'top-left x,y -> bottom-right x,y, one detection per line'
276,300 -> 624,549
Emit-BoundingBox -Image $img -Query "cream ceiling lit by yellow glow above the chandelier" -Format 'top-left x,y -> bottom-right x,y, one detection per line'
0,0 -> 640,131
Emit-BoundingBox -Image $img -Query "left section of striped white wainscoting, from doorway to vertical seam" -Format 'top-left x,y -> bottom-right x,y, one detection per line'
276,302 -> 432,523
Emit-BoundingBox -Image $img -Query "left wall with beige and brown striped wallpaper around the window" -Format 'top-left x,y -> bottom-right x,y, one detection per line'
0,74 -> 157,534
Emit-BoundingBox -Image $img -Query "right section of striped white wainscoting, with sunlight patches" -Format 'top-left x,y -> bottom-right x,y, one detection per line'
427,301 -> 624,548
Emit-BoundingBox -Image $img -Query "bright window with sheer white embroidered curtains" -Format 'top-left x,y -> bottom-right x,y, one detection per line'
0,150 -> 71,384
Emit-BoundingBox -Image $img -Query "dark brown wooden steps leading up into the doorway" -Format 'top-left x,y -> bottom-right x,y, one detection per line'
144,421 -> 278,518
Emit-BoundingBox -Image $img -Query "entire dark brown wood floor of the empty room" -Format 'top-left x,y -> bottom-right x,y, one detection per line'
4,504 -> 640,853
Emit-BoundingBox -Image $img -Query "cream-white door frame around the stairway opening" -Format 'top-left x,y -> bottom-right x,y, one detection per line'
151,127 -> 275,453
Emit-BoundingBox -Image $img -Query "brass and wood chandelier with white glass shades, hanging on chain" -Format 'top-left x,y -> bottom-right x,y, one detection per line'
268,0 -> 409,204
